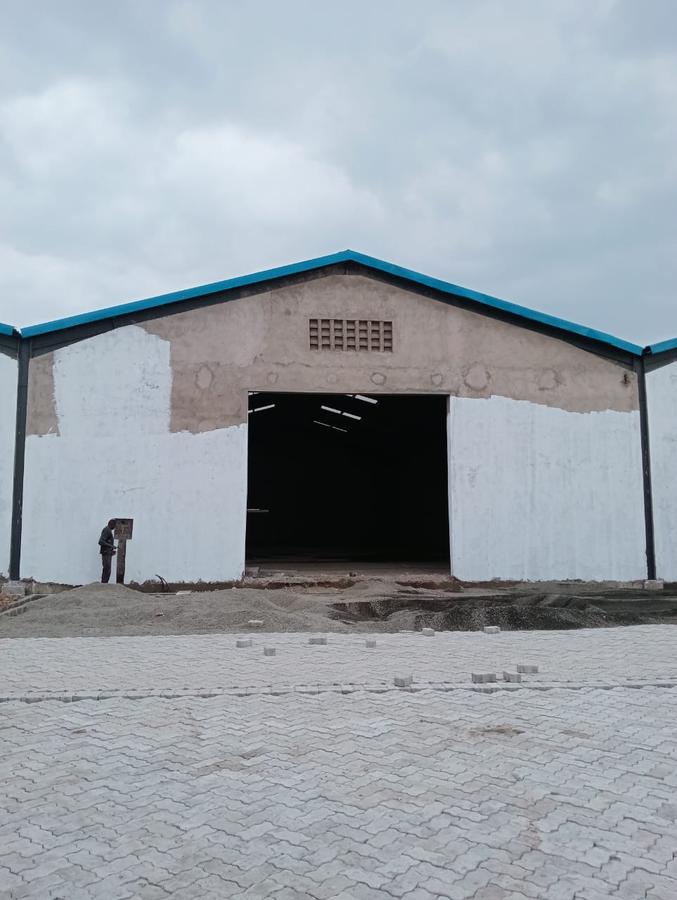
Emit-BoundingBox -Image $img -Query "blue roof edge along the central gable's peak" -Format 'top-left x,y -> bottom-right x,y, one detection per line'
21,250 -> 642,356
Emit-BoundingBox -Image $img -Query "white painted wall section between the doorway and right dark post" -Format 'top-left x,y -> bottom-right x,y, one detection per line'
448,391 -> 644,581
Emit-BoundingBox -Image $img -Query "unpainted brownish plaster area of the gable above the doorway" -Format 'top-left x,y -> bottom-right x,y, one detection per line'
137,273 -> 639,433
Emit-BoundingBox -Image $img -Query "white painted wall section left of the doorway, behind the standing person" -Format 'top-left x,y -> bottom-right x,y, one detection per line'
21,325 -> 247,584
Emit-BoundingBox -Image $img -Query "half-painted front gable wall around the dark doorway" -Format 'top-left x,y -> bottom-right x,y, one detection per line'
22,272 -> 646,583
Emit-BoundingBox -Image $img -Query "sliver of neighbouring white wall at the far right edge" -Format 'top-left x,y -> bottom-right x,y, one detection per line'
646,362 -> 677,581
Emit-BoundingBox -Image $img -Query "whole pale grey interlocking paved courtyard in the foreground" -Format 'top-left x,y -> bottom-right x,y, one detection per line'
0,626 -> 677,900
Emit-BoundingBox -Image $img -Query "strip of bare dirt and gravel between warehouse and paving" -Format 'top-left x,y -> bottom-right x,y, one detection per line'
0,576 -> 677,638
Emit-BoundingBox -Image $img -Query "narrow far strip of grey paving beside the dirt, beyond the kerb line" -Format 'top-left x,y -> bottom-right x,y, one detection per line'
0,625 -> 677,698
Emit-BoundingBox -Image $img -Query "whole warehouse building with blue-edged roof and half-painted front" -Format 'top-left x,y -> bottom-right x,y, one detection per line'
0,251 -> 677,583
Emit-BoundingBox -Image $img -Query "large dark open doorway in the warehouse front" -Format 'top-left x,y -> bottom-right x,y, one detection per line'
247,393 -> 449,572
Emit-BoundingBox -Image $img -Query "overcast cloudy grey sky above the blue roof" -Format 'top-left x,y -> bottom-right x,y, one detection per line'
0,0 -> 677,343
